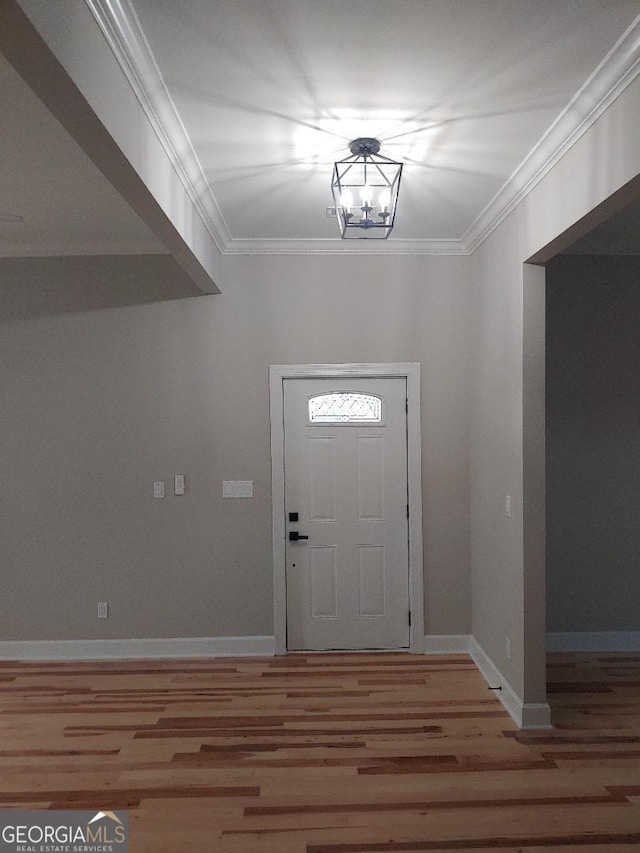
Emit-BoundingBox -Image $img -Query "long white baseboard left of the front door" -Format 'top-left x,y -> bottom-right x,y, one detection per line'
0,637 -> 274,661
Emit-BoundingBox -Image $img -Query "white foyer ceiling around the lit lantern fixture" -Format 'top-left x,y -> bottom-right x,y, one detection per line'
133,0 -> 640,248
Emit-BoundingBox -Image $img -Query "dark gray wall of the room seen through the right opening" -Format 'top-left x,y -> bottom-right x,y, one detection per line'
547,256 -> 640,631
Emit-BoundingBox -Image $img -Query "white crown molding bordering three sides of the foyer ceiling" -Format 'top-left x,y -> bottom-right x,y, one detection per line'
85,0 -> 640,255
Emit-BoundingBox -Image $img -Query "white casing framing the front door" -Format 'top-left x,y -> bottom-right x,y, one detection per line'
269,362 -> 424,655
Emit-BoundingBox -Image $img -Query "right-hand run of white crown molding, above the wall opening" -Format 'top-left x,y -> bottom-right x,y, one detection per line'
461,15 -> 640,253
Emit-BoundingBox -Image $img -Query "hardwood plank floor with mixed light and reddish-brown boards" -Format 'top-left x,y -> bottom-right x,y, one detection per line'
0,653 -> 640,853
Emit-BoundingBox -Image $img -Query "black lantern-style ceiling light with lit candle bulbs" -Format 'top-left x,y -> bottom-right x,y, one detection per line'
331,137 -> 402,240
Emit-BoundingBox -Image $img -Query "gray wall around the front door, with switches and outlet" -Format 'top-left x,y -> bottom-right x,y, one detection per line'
0,256 -> 471,639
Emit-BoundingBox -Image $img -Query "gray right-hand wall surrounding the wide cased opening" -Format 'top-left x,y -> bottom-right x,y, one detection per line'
469,71 -> 640,704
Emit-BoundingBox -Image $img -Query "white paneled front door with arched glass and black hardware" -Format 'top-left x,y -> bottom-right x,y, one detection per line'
284,377 -> 409,650
